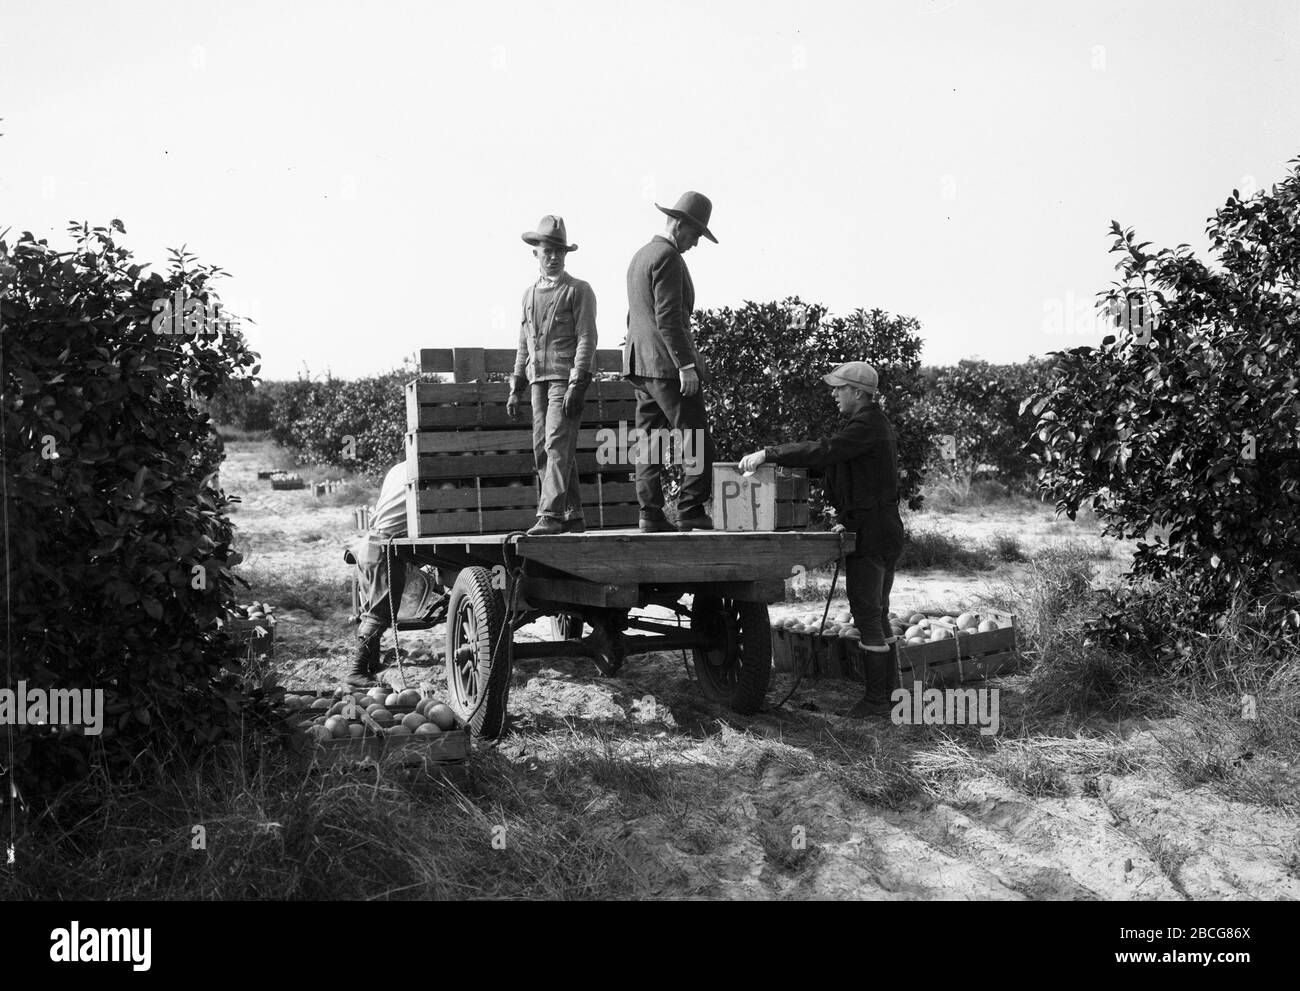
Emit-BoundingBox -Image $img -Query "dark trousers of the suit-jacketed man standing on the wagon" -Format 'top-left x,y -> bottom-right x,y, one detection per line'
628,375 -> 716,519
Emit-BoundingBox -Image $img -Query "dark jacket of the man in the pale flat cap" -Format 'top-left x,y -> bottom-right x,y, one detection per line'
767,403 -> 904,555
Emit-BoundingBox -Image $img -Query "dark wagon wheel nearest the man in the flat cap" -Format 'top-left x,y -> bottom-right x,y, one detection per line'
690,596 -> 772,715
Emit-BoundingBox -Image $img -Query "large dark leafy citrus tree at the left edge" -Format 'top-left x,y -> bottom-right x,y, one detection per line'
0,220 -> 270,795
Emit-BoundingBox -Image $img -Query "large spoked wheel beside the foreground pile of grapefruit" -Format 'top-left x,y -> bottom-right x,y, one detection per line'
447,568 -> 512,737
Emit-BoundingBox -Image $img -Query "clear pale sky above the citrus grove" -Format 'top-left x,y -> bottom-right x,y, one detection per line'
0,0 -> 1300,377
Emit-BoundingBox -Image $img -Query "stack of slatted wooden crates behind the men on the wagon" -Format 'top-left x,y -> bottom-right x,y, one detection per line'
406,347 -> 638,537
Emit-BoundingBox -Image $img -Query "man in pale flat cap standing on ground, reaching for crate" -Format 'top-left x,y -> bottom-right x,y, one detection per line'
740,362 -> 904,718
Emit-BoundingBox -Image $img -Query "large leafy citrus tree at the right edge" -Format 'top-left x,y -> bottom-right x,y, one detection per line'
1026,160 -> 1300,652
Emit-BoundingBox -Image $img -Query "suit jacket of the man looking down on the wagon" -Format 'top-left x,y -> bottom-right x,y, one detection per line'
623,237 -> 705,381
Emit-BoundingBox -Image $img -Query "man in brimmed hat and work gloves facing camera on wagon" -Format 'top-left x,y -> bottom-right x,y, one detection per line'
506,216 -> 595,537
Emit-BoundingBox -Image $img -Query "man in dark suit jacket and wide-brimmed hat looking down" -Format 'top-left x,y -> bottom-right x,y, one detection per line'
623,192 -> 718,533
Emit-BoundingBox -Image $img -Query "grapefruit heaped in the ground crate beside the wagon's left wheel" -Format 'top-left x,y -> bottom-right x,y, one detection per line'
285,687 -> 456,743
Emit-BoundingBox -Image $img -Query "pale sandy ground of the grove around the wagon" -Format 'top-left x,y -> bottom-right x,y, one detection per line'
222,442 -> 1300,900
